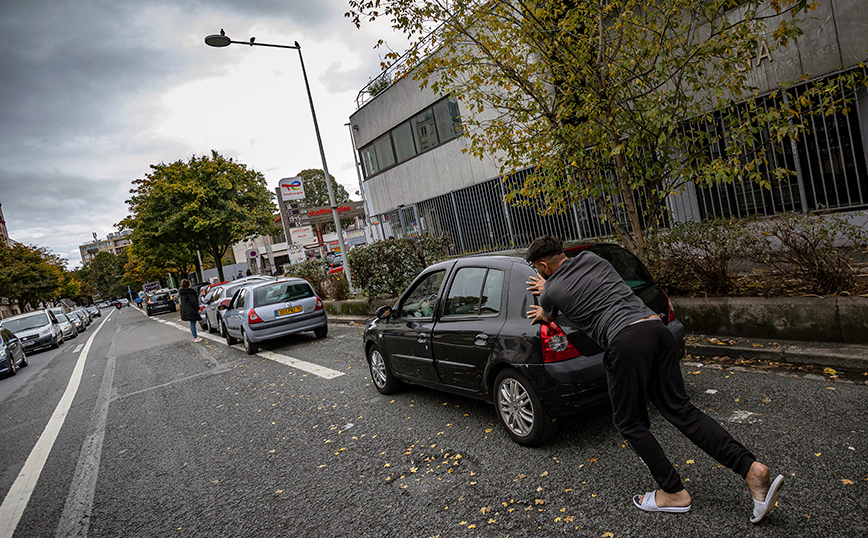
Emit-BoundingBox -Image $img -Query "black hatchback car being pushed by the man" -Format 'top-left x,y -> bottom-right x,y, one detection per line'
364,244 -> 684,446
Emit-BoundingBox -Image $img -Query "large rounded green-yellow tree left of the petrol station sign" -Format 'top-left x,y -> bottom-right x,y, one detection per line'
119,150 -> 276,280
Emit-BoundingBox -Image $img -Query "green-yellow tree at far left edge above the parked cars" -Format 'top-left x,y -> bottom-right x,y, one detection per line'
0,243 -> 64,309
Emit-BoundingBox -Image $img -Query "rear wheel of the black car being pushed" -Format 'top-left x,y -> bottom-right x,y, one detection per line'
492,368 -> 556,446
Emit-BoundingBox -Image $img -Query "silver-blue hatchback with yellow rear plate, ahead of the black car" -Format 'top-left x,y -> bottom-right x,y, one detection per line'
219,278 -> 328,355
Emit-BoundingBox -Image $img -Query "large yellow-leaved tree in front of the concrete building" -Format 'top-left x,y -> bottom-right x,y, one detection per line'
347,0 -> 865,256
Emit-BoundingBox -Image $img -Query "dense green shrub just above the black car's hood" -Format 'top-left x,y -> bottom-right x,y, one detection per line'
347,235 -> 449,299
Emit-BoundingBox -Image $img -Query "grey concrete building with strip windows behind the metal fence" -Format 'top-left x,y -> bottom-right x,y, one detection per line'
350,0 -> 868,254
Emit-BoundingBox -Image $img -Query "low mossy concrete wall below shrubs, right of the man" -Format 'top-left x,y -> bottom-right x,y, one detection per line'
672,297 -> 868,344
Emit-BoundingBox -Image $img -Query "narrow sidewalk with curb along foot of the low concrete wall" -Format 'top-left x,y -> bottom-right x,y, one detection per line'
329,314 -> 868,374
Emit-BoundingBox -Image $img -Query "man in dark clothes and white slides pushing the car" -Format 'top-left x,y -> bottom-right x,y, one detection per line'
526,236 -> 784,523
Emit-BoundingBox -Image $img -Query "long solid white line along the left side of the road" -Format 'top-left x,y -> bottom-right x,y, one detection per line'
0,316 -> 109,538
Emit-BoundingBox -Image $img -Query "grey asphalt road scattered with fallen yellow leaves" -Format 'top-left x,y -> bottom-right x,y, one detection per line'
0,307 -> 868,538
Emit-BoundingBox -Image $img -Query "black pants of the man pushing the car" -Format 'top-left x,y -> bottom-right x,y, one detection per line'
604,320 -> 756,493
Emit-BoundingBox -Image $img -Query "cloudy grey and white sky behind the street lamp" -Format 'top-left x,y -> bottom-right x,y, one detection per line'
0,0 -> 403,268
